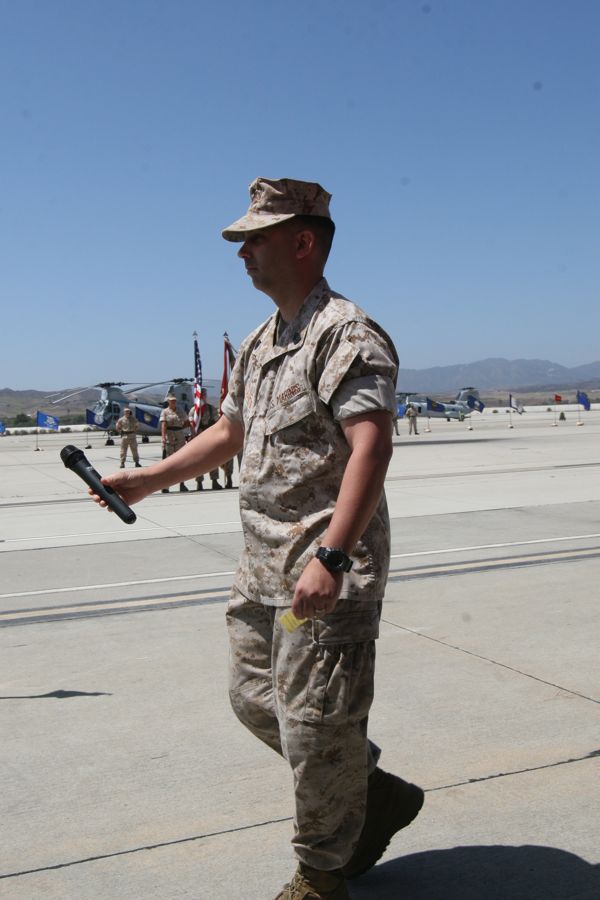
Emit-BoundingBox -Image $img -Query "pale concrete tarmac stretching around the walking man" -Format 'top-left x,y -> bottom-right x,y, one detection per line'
0,410 -> 600,900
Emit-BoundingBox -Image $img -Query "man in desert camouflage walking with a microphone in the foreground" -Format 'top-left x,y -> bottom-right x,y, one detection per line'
97,178 -> 424,900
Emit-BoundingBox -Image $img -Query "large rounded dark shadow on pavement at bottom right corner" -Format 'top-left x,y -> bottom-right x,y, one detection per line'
348,845 -> 600,900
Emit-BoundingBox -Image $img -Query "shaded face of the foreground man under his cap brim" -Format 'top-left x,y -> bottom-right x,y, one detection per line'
238,222 -> 296,297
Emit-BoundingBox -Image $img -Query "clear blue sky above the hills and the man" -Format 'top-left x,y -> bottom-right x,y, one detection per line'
0,0 -> 600,389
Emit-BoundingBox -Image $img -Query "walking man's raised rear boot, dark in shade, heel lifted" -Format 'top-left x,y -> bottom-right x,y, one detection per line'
341,769 -> 425,878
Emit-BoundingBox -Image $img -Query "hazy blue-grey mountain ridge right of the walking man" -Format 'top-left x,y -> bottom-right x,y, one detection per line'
398,359 -> 600,394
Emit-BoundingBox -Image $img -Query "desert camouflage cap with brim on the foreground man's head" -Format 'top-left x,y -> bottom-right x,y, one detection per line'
222,178 -> 331,241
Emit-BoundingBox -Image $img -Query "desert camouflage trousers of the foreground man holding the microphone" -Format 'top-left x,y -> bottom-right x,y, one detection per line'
227,589 -> 380,870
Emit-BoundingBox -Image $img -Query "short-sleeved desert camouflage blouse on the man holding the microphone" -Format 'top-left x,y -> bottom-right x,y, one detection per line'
223,279 -> 398,606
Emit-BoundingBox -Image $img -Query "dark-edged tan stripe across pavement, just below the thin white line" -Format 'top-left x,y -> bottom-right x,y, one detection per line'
0,547 -> 600,628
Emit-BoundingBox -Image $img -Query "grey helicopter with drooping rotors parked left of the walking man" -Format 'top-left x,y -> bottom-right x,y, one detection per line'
52,378 -> 194,446
